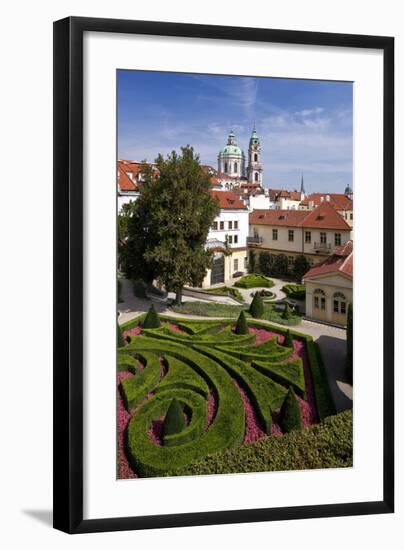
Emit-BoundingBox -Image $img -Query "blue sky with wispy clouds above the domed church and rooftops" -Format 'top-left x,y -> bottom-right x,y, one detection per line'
118,71 -> 352,193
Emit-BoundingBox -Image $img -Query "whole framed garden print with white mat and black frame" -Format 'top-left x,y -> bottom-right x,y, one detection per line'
54,17 -> 394,533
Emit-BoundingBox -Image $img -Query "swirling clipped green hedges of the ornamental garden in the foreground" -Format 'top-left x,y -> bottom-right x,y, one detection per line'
118,320 -> 332,477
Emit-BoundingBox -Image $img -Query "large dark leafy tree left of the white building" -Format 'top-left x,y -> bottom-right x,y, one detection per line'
123,146 -> 219,303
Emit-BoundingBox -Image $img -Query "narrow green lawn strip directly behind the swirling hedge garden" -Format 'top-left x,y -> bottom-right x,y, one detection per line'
171,302 -> 302,326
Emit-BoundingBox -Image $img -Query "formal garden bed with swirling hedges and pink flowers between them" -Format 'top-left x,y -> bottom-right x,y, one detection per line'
118,316 -> 335,478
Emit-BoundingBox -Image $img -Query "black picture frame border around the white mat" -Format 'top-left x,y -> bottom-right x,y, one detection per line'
53,17 -> 394,533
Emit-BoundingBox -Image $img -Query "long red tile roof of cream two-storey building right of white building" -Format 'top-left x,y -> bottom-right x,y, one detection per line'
250,203 -> 351,231
